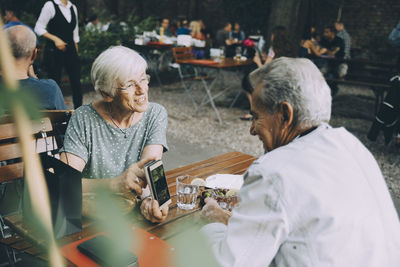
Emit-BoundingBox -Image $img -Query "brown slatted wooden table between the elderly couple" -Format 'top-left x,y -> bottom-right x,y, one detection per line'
1,152 -> 255,260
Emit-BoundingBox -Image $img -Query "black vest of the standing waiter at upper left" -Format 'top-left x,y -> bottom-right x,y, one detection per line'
47,1 -> 77,45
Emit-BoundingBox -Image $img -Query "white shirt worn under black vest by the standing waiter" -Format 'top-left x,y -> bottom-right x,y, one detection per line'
35,0 -> 79,43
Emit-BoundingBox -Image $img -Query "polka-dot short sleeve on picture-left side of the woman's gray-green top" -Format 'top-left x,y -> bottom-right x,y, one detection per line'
60,110 -> 90,163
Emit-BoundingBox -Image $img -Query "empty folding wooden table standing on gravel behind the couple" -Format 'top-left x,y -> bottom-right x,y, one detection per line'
176,58 -> 254,124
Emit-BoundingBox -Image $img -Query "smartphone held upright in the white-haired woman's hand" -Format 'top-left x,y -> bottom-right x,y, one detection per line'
144,160 -> 171,209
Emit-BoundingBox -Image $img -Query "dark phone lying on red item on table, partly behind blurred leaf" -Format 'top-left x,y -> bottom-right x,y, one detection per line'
78,235 -> 138,267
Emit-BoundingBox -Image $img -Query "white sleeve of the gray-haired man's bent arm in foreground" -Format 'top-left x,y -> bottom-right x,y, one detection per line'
201,168 -> 289,266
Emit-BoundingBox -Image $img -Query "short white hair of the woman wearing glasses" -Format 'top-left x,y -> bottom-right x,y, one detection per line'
91,46 -> 147,97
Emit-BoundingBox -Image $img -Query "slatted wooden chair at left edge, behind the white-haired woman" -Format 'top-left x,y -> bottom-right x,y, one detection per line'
0,110 -> 72,266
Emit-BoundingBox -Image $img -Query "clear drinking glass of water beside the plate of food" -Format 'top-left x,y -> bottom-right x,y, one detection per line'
176,175 -> 199,210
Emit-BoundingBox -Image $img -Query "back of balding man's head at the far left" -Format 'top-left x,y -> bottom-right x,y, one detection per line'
5,25 -> 36,59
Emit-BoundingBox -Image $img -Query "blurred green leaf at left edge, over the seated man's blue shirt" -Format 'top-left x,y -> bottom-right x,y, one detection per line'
0,83 -> 40,120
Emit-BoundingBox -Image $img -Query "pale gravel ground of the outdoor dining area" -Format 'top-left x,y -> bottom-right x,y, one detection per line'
66,78 -> 400,198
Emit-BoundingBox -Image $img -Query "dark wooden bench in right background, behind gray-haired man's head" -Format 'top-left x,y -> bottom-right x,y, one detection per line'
325,59 -> 396,113
